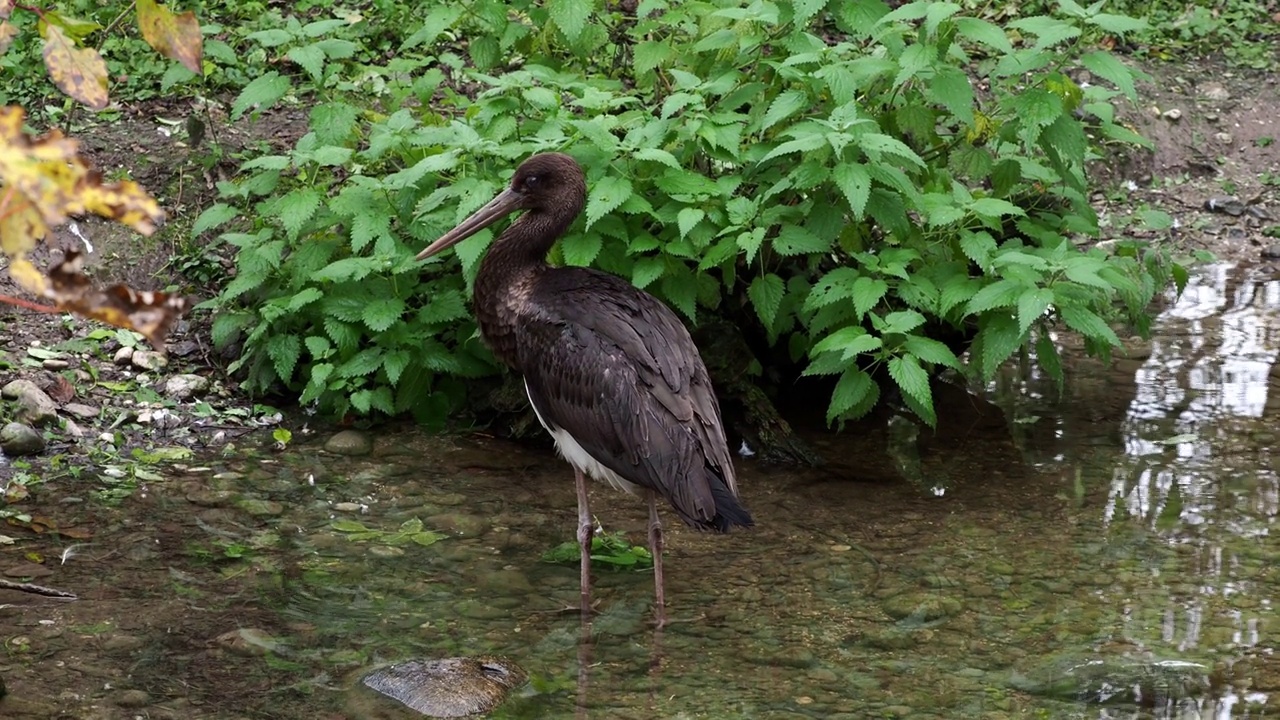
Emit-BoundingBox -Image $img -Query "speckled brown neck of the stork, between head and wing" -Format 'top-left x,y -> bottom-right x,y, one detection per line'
475,210 -> 577,363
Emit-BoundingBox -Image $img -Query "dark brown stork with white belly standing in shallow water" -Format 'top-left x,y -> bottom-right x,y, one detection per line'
417,152 -> 753,626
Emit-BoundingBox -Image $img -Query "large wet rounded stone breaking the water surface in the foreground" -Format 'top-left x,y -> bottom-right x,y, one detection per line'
364,656 -> 529,717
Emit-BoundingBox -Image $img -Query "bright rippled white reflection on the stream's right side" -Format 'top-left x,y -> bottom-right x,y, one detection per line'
1103,260 -> 1280,716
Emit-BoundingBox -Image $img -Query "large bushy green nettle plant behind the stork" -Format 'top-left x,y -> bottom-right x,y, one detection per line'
196,0 -> 1185,424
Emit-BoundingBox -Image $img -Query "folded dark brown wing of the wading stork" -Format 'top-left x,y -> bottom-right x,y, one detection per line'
517,269 -> 751,530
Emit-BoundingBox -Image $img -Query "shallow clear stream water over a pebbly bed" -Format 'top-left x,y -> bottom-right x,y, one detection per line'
0,260 -> 1280,719
